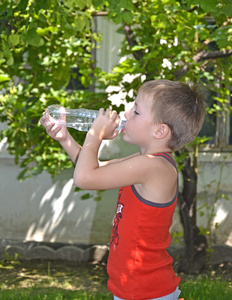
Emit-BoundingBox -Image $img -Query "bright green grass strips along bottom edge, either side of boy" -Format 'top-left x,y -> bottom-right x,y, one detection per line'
0,277 -> 232,300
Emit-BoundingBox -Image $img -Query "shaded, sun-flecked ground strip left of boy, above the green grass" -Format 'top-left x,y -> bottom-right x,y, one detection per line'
0,260 -> 109,299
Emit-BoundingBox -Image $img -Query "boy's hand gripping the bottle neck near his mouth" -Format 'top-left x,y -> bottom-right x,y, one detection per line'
89,108 -> 120,140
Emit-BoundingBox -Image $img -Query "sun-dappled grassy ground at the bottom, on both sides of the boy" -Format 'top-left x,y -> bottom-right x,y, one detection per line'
0,260 -> 232,300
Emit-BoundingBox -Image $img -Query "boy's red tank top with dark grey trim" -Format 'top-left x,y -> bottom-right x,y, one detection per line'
107,153 -> 180,300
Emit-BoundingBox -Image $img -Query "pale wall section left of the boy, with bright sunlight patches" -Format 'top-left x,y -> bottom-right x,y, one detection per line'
0,130 -> 138,244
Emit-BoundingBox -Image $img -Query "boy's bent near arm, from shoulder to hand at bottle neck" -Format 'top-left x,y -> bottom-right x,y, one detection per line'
74,111 -> 151,190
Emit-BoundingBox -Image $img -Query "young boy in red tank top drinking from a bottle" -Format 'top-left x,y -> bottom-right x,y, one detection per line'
41,80 -> 205,300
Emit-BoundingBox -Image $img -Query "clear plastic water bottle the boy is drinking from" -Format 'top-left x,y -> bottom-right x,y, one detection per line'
46,105 -> 126,131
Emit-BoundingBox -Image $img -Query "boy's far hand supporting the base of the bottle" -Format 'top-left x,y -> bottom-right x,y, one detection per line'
40,110 -> 68,142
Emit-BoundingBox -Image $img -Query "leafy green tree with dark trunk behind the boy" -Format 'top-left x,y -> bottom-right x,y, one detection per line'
0,0 -> 232,272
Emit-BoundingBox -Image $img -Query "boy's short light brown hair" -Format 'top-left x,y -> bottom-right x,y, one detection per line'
139,80 -> 205,151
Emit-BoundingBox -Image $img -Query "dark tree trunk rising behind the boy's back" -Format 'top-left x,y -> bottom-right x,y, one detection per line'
176,150 -> 207,274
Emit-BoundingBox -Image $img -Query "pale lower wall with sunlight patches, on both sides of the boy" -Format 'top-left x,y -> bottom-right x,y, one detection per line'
0,130 -> 232,246
